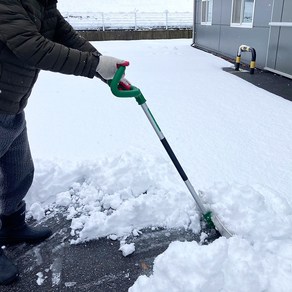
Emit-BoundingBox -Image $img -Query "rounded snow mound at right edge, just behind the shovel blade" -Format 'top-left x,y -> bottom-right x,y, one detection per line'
204,183 -> 292,243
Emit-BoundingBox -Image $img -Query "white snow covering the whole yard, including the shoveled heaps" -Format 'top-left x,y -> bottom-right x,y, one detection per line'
26,38 -> 292,292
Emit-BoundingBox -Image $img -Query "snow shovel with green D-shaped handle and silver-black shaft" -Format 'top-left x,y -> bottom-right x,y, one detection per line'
108,66 -> 232,238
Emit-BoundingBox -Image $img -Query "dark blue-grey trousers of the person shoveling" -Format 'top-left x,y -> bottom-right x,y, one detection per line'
0,112 -> 34,215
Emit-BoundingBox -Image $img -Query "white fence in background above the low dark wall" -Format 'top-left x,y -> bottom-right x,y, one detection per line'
63,11 -> 193,31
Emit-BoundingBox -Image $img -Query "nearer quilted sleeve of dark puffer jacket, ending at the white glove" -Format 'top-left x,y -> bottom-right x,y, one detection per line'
0,0 -> 99,78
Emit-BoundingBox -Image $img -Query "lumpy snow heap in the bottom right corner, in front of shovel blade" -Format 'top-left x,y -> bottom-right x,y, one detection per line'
129,236 -> 292,292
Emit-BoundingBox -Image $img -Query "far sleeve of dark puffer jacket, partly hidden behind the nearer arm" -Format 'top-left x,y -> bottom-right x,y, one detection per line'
55,9 -> 97,52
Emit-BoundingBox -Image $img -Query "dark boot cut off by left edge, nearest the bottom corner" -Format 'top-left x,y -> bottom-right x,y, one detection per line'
0,248 -> 19,285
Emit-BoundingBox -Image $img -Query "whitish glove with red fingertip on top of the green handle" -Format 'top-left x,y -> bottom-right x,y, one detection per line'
96,55 -> 130,80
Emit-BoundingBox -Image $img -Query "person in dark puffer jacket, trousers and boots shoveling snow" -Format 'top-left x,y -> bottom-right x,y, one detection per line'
0,0 -> 130,285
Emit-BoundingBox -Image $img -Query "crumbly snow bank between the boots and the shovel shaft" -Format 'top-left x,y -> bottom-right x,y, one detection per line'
27,152 -> 200,243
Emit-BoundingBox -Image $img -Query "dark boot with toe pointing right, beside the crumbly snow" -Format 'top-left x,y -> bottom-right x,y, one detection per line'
0,201 -> 52,245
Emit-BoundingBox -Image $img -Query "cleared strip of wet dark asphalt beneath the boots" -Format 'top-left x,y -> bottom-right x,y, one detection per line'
0,214 -> 216,292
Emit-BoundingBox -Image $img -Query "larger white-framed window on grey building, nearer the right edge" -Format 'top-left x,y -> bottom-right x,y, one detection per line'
231,0 -> 255,27
